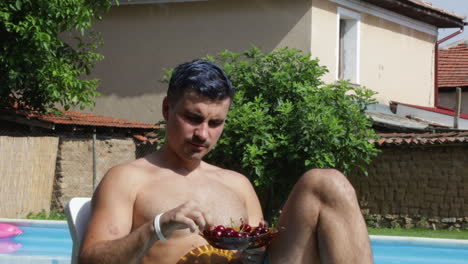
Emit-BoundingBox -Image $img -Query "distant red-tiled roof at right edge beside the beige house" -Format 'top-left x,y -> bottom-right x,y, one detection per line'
438,43 -> 468,87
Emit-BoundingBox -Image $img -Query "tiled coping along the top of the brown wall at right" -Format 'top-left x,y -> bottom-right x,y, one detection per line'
370,131 -> 468,146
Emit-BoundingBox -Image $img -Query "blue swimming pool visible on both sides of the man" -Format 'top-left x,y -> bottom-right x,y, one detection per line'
0,219 -> 468,264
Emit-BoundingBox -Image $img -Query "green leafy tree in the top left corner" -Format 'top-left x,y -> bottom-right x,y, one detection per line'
0,0 -> 111,111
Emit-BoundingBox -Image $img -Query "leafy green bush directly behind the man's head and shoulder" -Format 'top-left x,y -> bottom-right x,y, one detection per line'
207,48 -> 378,217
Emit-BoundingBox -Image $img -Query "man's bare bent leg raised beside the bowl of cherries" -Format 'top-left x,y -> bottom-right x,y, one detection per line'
268,169 -> 373,264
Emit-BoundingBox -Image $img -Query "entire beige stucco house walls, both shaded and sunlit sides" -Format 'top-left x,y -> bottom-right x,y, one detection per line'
82,0 -> 436,122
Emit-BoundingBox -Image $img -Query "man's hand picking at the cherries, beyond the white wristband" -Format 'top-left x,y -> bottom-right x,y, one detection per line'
159,201 -> 213,238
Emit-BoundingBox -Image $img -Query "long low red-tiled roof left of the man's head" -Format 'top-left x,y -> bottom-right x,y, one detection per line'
0,109 -> 159,129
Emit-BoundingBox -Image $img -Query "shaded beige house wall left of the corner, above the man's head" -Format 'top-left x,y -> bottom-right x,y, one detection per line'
85,0 -> 312,122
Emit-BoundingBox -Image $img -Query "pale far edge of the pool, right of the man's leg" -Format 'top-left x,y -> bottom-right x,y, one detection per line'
369,235 -> 468,249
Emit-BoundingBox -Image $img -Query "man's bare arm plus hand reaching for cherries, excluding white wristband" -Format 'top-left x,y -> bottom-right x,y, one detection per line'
79,165 -> 212,264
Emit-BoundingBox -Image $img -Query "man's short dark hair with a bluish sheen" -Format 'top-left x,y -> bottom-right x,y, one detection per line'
167,60 -> 234,103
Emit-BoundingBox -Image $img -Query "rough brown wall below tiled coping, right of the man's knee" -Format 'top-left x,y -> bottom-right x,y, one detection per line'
349,145 -> 468,228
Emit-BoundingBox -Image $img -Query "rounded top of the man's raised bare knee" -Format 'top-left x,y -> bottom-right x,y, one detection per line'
298,169 -> 356,205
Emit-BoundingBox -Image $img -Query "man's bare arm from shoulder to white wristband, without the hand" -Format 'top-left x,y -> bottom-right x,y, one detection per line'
79,165 -> 157,264
